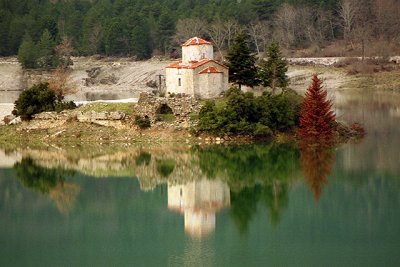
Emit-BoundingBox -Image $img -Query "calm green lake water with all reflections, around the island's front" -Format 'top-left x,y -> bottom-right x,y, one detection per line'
0,89 -> 400,266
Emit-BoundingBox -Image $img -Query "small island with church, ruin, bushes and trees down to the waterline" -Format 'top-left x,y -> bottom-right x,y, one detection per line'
0,34 -> 364,148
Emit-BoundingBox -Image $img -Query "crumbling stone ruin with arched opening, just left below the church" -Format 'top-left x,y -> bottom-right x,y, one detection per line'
135,92 -> 201,123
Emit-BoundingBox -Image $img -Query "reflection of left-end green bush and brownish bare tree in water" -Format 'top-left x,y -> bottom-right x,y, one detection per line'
14,158 -> 80,213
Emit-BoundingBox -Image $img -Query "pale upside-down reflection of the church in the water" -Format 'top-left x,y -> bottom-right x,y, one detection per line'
168,179 -> 230,237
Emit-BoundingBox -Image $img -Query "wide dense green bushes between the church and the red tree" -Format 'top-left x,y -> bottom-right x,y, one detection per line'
198,88 -> 300,137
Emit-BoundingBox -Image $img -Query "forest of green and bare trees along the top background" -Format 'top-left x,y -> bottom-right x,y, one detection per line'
0,0 -> 400,59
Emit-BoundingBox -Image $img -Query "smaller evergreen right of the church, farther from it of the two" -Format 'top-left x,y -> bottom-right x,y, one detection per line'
258,43 -> 289,91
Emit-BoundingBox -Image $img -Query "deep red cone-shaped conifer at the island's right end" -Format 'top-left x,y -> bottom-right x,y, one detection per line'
299,74 -> 335,141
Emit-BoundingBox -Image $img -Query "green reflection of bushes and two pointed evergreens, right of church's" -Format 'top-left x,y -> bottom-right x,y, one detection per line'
197,143 -> 299,233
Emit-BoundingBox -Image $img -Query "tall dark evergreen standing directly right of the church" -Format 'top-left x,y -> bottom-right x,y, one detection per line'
227,33 -> 260,89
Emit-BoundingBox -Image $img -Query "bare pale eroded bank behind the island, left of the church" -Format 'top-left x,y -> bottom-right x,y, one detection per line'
0,57 -> 170,103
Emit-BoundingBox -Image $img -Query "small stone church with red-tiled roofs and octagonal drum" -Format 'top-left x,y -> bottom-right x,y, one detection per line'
165,37 -> 228,98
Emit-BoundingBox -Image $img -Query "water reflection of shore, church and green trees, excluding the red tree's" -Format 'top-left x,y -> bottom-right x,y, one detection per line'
5,143 -> 299,237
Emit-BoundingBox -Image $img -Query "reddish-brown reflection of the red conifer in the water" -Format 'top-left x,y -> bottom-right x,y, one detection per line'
300,141 -> 336,201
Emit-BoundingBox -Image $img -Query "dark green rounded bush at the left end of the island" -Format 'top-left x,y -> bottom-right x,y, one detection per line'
12,83 -> 76,120
